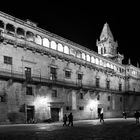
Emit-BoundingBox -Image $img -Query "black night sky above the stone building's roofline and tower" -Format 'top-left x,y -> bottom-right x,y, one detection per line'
0,0 -> 140,66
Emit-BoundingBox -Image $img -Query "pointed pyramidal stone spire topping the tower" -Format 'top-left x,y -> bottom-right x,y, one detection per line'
100,23 -> 114,40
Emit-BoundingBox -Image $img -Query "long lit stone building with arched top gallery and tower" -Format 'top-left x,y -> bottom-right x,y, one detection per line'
0,12 -> 140,123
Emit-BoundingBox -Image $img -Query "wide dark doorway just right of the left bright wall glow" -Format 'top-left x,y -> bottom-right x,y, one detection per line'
51,108 -> 60,122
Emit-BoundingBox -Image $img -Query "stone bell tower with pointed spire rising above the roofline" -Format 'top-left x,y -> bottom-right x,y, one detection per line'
96,23 -> 123,63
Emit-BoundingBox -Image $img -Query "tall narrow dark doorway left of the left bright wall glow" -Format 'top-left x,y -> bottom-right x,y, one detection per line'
27,106 -> 34,123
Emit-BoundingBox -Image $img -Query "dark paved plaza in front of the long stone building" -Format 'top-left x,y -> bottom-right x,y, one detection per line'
0,118 -> 140,140
